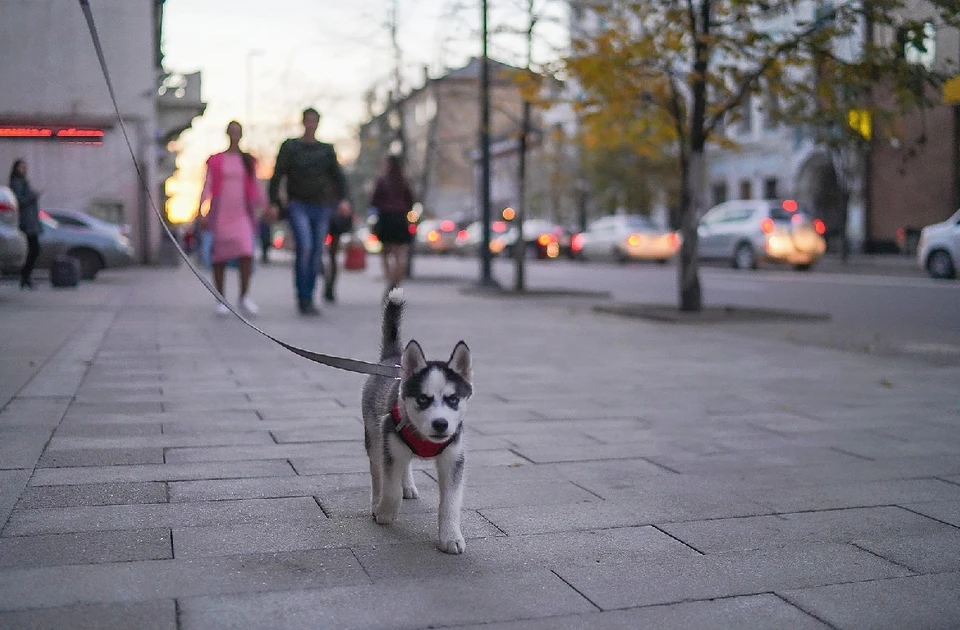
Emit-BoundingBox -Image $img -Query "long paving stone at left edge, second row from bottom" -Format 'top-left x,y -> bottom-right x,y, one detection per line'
0,549 -> 370,621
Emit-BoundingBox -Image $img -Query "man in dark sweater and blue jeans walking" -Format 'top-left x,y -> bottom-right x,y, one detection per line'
270,107 -> 350,315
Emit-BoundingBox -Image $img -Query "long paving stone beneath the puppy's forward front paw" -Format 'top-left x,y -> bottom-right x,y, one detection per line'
173,506 -> 501,558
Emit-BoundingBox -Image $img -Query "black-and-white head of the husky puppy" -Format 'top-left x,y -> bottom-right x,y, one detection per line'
400,341 -> 473,442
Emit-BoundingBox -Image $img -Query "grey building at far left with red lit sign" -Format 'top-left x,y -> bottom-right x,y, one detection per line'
0,0 -> 204,263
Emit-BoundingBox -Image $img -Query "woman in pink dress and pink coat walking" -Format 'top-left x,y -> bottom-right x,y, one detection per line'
197,120 -> 264,315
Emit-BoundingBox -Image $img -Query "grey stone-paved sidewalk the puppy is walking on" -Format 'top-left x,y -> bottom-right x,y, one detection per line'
0,259 -> 960,630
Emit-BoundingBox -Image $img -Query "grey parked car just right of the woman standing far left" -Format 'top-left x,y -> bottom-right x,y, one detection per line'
37,210 -> 134,280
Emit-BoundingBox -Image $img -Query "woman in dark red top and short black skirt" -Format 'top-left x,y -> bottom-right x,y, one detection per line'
370,155 -> 413,289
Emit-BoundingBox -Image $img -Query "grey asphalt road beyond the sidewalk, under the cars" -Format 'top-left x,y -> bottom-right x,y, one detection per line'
424,258 -> 960,364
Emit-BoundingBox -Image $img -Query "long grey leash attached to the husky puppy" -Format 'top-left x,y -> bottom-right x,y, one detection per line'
79,0 -> 400,378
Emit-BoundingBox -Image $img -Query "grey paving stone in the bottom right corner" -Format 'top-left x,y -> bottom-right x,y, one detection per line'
782,573 -> 960,630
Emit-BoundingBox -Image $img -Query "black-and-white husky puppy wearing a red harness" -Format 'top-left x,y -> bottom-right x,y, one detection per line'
361,289 -> 473,554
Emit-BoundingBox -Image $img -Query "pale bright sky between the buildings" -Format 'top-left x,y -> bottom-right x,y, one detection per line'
157,0 -> 565,222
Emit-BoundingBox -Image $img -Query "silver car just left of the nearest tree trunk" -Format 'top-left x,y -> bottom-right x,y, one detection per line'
570,214 -> 680,263
